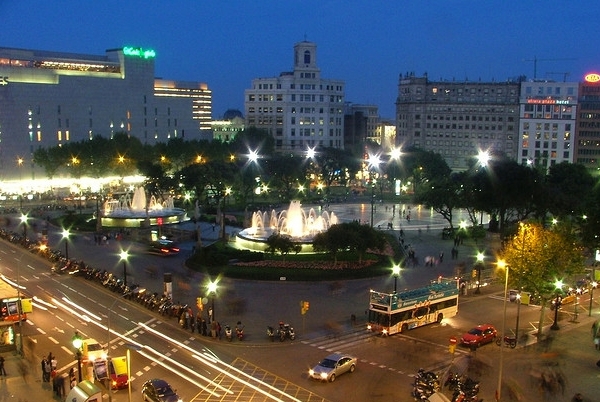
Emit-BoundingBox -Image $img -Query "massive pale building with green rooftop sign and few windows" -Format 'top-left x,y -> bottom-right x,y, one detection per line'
0,47 -> 212,180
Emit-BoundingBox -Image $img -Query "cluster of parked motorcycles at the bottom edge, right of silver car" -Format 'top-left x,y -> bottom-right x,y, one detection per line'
412,369 -> 483,402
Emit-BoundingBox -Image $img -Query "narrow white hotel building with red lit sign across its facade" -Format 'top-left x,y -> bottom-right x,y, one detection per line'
516,80 -> 579,171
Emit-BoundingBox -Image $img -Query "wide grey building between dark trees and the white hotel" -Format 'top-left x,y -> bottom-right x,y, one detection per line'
396,74 -> 520,171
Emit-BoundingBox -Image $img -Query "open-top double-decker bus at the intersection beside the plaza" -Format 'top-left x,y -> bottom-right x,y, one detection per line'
367,277 -> 460,335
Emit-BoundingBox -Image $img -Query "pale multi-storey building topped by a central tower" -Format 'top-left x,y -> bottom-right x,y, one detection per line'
244,41 -> 344,152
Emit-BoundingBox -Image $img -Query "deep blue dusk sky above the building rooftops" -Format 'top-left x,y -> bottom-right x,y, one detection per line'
0,0 -> 600,118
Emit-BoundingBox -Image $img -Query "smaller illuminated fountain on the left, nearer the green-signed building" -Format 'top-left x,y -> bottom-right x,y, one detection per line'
101,187 -> 188,227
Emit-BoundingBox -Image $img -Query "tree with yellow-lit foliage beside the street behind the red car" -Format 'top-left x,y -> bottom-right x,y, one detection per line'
501,223 -> 584,336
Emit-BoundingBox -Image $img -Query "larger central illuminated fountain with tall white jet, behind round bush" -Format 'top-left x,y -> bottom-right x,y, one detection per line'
236,201 -> 338,251
